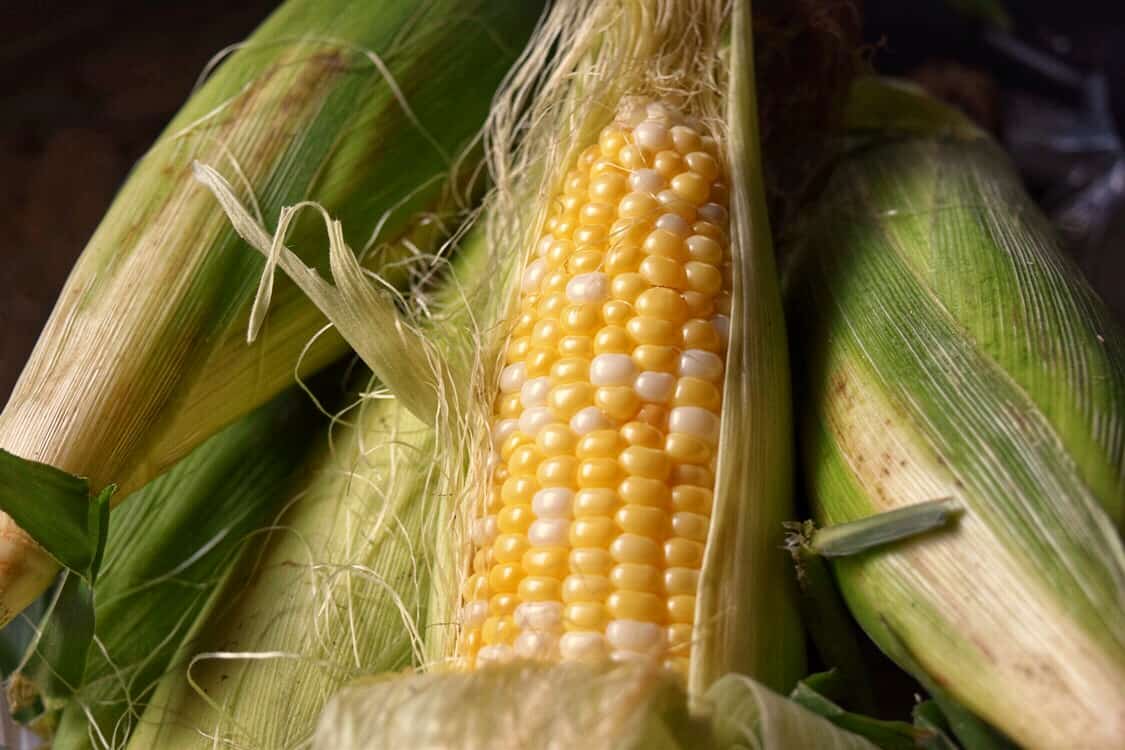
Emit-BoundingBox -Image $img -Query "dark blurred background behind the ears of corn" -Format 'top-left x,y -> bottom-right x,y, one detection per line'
0,0 -> 1125,403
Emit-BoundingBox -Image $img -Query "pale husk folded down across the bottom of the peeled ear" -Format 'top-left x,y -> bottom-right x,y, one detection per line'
313,663 -> 875,750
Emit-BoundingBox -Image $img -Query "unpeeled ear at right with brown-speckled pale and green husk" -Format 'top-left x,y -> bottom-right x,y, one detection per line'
789,77 -> 1125,748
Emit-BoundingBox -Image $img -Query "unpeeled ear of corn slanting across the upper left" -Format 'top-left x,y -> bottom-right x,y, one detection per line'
0,0 -> 538,622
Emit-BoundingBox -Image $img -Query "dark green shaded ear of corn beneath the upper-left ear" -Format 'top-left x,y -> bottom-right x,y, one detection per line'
16,392 -> 316,750
